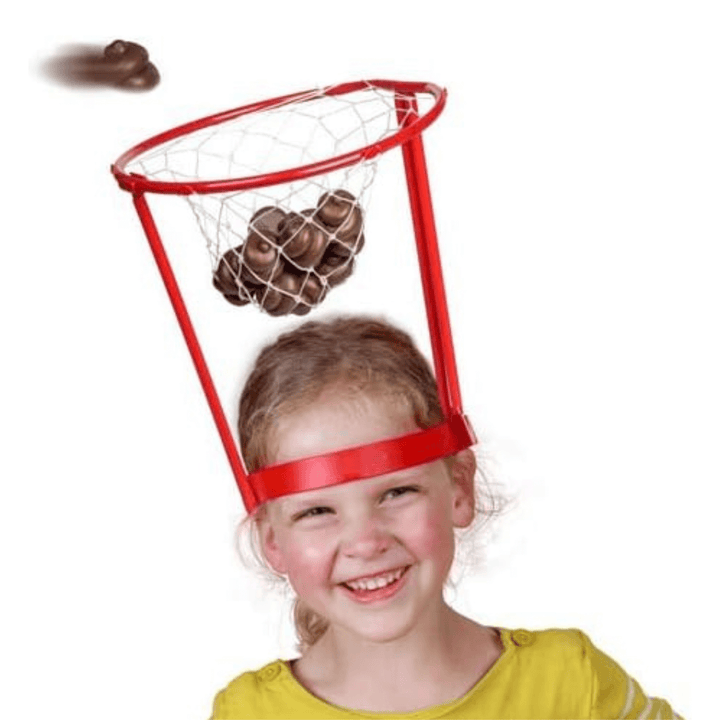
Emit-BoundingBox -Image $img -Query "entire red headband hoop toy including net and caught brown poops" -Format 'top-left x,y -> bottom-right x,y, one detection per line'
112,80 -> 475,512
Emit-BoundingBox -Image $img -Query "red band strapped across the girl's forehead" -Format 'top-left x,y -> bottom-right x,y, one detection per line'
247,414 -> 477,512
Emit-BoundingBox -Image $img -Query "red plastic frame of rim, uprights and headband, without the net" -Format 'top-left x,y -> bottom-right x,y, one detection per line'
111,80 -> 476,513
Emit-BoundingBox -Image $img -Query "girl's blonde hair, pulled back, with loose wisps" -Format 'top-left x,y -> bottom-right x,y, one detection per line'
238,316 -> 500,651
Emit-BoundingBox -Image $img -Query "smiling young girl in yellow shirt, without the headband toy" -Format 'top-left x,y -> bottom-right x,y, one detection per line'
213,317 -> 679,720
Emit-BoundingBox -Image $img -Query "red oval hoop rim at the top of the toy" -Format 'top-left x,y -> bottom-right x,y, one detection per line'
110,80 -> 447,195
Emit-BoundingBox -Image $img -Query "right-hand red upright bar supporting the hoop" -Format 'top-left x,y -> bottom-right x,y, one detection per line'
395,95 -> 462,417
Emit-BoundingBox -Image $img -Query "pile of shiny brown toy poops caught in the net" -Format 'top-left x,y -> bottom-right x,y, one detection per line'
213,190 -> 365,316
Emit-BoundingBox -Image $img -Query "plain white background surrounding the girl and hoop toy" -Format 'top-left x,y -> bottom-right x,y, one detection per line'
0,0 -> 720,720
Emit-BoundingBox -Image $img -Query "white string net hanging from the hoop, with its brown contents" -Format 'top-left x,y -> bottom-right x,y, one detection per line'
127,84 -> 422,315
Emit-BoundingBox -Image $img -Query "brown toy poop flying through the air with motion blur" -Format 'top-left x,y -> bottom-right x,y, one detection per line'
43,40 -> 160,90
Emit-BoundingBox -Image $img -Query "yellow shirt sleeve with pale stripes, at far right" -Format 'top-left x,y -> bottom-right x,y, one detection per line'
583,635 -> 683,720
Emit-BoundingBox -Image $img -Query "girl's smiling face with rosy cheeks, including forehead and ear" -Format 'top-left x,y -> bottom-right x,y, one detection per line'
261,395 -> 475,642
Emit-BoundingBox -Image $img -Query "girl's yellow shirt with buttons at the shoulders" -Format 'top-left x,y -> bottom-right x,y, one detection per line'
212,630 -> 682,720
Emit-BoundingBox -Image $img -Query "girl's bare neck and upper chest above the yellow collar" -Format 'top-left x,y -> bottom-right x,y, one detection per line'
293,602 -> 501,712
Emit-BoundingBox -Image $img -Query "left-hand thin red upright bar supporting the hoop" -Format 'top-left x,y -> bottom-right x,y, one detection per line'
133,188 -> 257,507
